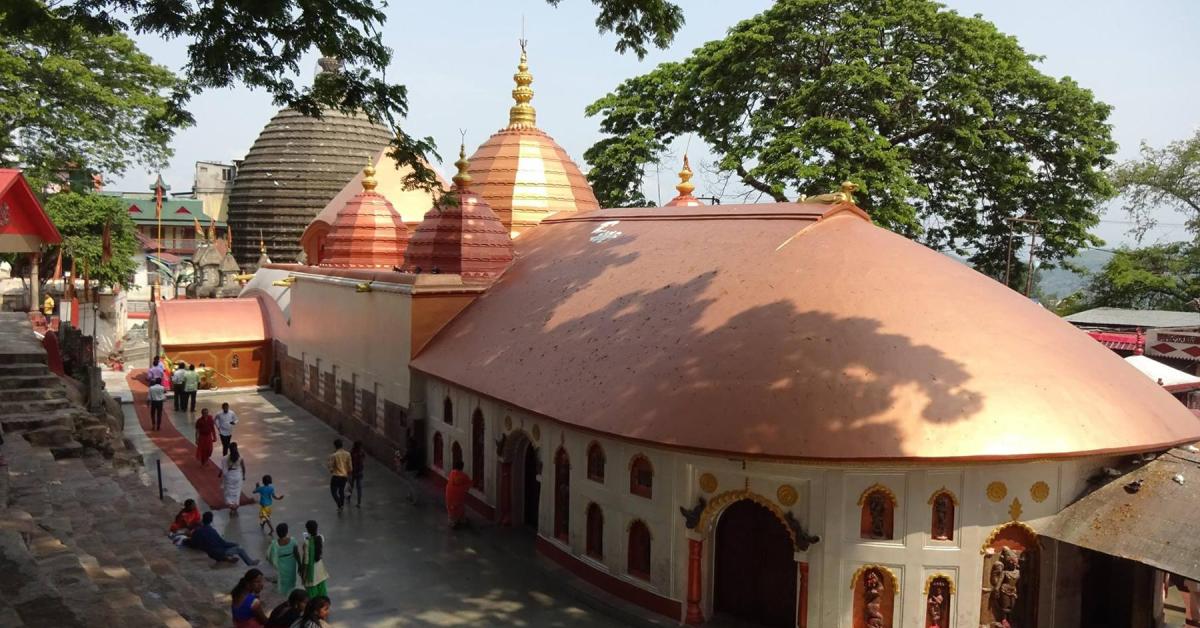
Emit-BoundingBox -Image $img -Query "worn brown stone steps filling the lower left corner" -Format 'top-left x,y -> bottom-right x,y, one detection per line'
0,439 -> 229,627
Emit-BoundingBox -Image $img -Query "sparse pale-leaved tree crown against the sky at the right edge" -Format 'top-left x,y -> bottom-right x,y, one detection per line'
1112,131 -> 1200,240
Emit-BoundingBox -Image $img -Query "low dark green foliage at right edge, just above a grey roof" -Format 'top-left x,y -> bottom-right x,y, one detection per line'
1062,243 -> 1200,313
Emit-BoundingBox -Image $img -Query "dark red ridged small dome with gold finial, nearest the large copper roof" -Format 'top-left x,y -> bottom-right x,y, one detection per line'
404,146 -> 512,281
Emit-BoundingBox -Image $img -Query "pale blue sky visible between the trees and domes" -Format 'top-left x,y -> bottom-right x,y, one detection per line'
108,0 -> 1200,246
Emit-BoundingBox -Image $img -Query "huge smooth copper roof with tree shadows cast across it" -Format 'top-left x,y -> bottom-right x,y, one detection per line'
413,204 -> 1200,460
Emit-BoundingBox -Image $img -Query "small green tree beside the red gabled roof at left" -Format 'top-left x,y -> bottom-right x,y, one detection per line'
42,192 -> 138,288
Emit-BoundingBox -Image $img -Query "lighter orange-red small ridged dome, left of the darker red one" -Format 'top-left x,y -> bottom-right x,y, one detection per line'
320,165 -> 410,269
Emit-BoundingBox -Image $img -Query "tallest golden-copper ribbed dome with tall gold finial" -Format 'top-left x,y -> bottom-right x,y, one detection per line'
470,48 -> 600,235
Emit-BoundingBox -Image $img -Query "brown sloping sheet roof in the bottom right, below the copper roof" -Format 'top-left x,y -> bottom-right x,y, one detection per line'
1038,448 -> 1200,580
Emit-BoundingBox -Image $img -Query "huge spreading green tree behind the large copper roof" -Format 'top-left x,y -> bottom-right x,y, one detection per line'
584,0 -> 1116,277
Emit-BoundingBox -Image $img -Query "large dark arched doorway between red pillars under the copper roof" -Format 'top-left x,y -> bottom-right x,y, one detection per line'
713,500 -> 797,628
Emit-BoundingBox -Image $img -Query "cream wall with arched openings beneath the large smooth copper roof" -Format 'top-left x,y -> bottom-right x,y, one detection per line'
427,382 -> 1112,628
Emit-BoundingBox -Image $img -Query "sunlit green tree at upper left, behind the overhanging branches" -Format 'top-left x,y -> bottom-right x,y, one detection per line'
0,25 -> 190,190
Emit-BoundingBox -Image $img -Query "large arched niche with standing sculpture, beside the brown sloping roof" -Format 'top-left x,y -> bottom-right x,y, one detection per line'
979,521 -> 1039,628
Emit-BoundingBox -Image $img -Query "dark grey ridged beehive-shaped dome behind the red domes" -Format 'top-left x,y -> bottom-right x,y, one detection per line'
229,109 -> 391,267
